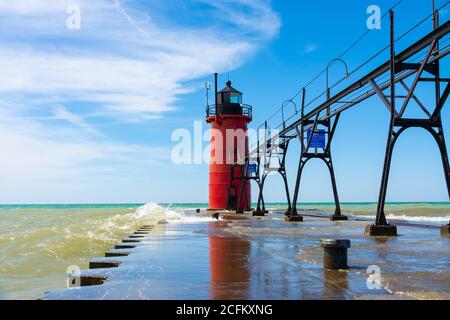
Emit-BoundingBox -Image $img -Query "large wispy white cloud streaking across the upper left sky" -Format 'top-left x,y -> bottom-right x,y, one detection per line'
0,0 -> 279,119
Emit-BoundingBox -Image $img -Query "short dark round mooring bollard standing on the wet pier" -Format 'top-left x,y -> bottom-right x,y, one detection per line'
320,239 -> 350,270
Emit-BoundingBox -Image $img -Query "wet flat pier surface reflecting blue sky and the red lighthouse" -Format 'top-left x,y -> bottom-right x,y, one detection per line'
43,214 -> 450,300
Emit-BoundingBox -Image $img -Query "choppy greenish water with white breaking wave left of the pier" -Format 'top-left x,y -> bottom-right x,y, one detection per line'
0,203 -> 212,299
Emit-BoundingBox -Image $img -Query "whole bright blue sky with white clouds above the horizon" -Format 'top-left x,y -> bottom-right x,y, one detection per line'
0,0 -> 450,203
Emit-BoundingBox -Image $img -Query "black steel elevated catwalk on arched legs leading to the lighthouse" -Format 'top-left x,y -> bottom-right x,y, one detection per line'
232,10 -> 450,236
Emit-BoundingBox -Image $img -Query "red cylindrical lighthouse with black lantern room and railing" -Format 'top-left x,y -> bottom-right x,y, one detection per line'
206,74 -> 252,210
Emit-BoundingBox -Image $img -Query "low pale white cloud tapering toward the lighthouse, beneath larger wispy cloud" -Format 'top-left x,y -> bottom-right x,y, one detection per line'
0,104 -> 169,185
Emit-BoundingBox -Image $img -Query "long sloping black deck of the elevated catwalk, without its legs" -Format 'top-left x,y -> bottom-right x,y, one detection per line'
247,21 -> 450,160
